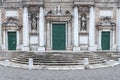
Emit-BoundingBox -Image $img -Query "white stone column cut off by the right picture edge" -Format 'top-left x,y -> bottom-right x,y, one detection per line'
116,8 -> 120,51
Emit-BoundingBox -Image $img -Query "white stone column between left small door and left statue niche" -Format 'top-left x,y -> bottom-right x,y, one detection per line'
22,6 -> 29,51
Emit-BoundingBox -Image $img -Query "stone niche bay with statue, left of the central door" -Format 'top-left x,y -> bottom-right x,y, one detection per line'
28,5 -> 39,50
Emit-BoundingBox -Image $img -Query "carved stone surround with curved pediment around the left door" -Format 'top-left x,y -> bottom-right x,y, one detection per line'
2,17 -> 22,50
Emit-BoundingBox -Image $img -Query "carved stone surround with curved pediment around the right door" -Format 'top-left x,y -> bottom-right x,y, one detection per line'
96,17 -> 116,50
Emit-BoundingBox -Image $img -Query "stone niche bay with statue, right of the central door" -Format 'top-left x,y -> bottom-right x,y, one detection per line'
79,5 -> 89,51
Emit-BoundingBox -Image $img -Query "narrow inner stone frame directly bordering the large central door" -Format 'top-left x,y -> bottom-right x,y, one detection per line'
50,22 -> 68,50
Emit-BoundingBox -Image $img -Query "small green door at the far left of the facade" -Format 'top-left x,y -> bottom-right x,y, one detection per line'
8,32 -> 16,50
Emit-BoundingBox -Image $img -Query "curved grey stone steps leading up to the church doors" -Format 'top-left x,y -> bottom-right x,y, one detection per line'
11,52 -> 105,65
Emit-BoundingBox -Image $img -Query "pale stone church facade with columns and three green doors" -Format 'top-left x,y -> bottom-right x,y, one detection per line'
0,0 -> 120,51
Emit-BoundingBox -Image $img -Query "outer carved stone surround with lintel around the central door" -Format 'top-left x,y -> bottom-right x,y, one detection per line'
45,15 -> 72,50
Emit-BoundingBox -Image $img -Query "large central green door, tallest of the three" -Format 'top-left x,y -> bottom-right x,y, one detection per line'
52,24 -> 66,50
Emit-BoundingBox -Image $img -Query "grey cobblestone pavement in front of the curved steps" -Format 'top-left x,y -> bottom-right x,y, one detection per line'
0,65 -> 120,80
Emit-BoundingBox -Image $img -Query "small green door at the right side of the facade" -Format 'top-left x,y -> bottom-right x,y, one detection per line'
101,32 -> 110,50
